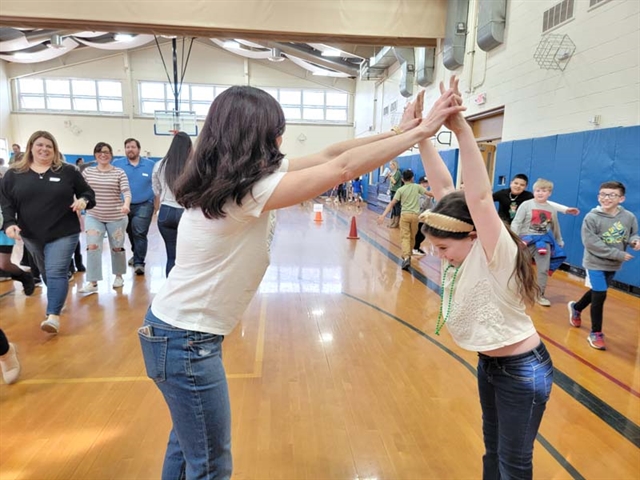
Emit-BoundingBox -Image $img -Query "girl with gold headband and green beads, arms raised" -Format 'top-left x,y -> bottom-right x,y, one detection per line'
419,77 -> 553,479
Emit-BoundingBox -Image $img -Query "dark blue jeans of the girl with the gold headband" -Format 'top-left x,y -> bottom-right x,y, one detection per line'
478,342 -> 553,480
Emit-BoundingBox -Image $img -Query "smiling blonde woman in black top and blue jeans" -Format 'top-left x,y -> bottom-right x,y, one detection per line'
0,131 -> 95,333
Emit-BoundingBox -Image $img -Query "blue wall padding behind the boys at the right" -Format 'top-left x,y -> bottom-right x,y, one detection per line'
494,126 -> 640,287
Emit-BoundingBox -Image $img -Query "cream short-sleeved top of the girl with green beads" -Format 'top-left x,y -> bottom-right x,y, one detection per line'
442,225 -> 536,352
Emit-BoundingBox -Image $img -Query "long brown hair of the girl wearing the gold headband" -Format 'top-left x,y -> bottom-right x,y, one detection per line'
423,191 -> 540,305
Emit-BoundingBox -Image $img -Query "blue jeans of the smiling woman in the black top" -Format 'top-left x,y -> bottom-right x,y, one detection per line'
22,233 -> 80,315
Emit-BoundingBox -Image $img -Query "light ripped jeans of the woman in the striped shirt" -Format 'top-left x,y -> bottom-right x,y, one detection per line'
84,215 -> 129,282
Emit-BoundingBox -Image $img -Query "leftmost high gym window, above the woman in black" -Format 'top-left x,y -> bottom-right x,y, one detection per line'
16,78 -> 124,115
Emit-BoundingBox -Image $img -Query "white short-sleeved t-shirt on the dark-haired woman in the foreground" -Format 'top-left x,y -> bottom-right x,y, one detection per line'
151,159 -> 289,335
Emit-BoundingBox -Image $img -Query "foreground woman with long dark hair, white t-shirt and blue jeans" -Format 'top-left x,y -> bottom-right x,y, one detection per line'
138,86 -> 463,480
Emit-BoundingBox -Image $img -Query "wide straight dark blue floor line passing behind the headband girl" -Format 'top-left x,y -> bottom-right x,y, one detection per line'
329,210 -> 640,448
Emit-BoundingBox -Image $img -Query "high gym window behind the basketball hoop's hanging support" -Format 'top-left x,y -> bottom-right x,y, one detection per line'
138,82 -> 229,118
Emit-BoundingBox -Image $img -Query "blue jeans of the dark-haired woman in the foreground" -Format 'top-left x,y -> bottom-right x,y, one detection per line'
138,308 -> 232,480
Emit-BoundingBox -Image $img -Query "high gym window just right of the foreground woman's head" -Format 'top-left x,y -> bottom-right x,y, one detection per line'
263,88 -> 349,124
